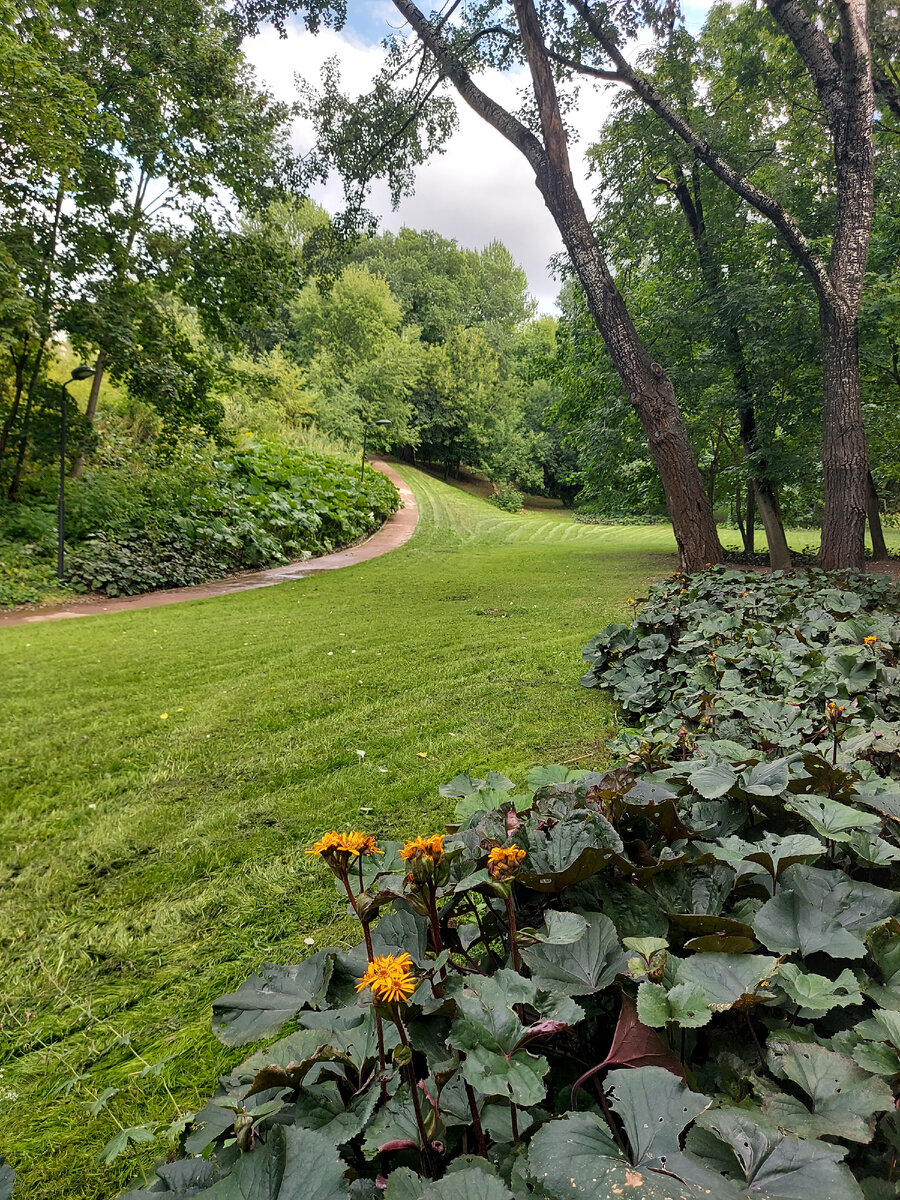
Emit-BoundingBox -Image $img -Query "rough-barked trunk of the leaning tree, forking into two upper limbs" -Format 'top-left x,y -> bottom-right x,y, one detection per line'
394,0 -> 721,570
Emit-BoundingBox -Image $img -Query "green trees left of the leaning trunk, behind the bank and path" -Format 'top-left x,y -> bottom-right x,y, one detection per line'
0,0 -> 577,504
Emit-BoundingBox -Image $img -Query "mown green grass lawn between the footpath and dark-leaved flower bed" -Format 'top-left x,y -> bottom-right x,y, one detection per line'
0,469 -> 892,1200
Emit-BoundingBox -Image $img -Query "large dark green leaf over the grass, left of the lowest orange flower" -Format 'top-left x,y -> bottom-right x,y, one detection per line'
212,950 -> 334,1046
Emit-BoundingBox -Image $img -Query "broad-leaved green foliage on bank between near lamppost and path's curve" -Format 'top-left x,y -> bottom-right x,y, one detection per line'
67,439 -> 398,595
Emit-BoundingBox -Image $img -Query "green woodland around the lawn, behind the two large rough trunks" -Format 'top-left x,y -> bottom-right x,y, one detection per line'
0,0 -> 900,604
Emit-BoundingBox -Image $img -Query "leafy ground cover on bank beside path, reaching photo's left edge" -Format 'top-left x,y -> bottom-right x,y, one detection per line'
0,437 -> 398,606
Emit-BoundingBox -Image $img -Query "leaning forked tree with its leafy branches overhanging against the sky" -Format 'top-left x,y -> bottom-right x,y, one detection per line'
245,0 -> 721,569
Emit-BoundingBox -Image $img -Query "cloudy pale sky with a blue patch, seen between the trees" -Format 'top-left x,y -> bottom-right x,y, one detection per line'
245,0 -> 706,312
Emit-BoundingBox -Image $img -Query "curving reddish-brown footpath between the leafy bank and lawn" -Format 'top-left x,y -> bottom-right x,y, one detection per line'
0,458 -> 419,625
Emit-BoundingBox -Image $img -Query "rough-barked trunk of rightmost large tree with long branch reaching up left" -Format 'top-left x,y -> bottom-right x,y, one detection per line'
570,0 -> 875,570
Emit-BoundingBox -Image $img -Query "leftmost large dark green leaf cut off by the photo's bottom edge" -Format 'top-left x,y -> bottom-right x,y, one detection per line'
205,1126 -> 348,1200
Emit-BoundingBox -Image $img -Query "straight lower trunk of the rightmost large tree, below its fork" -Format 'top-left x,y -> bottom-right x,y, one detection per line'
818,302 -> 869,571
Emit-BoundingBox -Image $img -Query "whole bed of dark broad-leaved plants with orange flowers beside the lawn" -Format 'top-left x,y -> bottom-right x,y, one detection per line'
116,572 -> 900,1200
